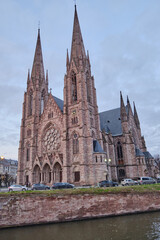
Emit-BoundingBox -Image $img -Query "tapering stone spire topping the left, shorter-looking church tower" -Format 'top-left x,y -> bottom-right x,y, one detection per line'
31,29 -> 45,84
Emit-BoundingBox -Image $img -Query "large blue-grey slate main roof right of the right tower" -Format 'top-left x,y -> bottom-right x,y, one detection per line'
99,108 -> 122,136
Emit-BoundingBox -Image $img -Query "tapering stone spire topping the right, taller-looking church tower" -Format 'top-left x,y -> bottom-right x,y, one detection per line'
70,5 -> 86,60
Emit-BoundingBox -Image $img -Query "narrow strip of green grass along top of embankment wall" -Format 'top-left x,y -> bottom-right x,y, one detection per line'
0,184 -> 160,197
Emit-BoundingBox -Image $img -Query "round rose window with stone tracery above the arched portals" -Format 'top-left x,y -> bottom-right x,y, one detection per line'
44,128 -> 60,151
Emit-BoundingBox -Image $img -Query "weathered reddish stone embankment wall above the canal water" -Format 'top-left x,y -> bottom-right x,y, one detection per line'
0,192 -> 160,228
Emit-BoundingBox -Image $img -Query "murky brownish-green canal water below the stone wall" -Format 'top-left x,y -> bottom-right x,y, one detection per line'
0,212 -> 160,240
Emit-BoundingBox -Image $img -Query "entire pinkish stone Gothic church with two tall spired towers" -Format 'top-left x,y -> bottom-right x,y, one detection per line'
18,6 -> 154,185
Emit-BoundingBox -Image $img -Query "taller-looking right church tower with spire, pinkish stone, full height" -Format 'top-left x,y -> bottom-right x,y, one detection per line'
63,6 -> 106,185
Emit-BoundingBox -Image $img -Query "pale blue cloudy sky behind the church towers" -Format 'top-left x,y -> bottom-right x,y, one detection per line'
0,0 -> 160,159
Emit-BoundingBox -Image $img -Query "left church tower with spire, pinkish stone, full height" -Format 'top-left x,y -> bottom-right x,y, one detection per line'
18,29 -> 48,184
